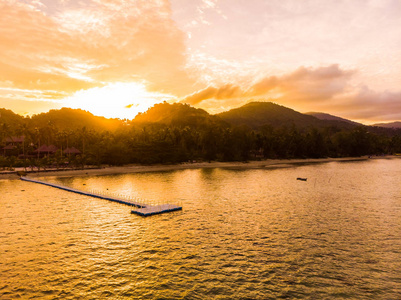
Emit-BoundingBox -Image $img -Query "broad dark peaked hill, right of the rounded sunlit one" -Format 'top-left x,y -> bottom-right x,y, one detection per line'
217,102 -> 354,129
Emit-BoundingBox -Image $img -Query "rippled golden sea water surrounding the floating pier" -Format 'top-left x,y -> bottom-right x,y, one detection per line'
0,159 -> 401,299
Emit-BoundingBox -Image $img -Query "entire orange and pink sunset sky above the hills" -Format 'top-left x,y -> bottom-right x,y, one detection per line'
0,0 -> 401,124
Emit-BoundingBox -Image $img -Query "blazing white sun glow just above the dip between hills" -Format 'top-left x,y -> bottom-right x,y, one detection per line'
63,82 -> 175,119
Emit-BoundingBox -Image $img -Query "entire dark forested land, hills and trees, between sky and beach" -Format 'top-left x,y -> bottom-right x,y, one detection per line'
0,102 -> 401,168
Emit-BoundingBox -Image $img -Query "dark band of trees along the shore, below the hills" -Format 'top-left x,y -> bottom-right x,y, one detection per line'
0,121 -> 401,168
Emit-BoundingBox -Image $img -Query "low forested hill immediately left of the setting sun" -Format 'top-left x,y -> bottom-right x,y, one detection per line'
29,107 -> 123,131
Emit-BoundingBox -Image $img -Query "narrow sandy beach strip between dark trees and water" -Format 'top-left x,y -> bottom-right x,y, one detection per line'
0,155 -> 401,180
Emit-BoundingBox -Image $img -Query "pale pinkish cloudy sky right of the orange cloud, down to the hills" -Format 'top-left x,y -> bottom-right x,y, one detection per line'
172,0 -> 401,122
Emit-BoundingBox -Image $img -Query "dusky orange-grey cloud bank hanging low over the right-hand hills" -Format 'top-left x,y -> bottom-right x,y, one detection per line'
181,64 -> 401,122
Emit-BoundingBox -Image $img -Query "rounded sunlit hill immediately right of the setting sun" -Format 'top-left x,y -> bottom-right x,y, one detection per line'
132,102 -> 228,127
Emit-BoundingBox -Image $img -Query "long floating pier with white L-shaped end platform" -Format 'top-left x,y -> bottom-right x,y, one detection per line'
20,177 -> 182,217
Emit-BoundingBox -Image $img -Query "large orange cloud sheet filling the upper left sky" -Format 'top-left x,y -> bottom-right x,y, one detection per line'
0,0 -> 193,98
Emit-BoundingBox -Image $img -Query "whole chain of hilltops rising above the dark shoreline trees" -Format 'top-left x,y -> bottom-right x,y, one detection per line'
0,102 -> 401,133
